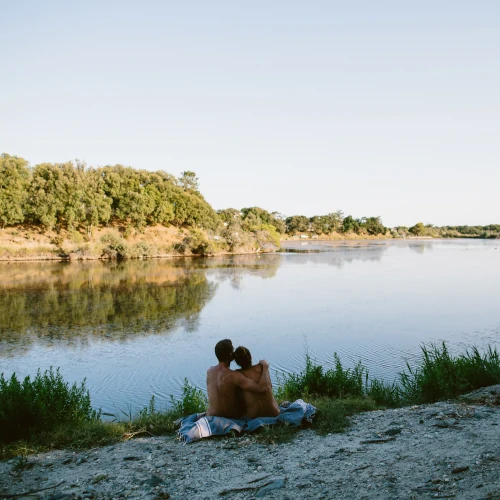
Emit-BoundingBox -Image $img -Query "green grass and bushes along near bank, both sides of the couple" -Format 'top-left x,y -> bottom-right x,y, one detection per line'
0,343 -> 500,462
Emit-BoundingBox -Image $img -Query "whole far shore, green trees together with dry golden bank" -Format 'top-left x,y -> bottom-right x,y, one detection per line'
0,153 -> 500,261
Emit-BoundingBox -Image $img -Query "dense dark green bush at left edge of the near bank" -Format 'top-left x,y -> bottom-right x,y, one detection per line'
0,368 -> 100,443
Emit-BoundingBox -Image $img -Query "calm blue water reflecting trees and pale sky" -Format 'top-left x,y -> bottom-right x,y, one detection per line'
0,240 -> 500,413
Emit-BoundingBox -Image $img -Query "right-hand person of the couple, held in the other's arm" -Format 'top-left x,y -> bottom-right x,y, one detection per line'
234,347 -> 280,418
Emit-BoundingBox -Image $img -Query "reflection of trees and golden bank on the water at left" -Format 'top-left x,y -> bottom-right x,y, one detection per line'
0,255 -> 280,356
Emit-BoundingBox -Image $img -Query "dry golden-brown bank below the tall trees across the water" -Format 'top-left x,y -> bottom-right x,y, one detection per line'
0,225 -> 279,262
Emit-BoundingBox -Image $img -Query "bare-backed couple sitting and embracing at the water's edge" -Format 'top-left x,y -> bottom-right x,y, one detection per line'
207,339 -> 280,419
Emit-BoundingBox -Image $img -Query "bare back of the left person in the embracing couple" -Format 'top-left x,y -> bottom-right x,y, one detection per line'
207,364 -> 245,418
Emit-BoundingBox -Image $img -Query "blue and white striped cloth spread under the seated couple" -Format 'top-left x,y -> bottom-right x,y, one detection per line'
178,399 -> 316,443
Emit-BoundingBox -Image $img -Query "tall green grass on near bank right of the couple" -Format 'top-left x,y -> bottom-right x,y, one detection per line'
276,342 -> 500,408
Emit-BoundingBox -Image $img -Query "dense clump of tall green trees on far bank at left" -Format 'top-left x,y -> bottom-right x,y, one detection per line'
0,154 -> 218,231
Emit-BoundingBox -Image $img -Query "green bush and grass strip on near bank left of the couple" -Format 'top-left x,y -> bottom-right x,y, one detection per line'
0,376 -> 207,459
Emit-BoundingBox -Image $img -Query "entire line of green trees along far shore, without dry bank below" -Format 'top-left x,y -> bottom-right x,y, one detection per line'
0,153 -> 500,241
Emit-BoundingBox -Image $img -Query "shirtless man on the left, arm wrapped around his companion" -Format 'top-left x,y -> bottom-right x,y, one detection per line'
207,339 -> 271,418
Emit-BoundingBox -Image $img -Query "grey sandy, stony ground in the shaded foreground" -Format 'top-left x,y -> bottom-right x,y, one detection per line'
0,386 -> 500,500
